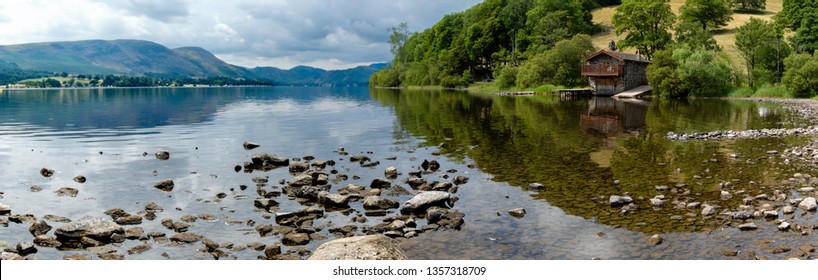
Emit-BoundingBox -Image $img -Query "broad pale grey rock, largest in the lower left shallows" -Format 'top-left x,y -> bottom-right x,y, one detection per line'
54,216 -> 124,241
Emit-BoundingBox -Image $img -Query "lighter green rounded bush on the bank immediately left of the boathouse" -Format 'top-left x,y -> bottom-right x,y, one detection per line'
517,34 -> 595,88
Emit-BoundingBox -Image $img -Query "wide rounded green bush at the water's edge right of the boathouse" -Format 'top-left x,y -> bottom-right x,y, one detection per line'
647,45 -> 732,98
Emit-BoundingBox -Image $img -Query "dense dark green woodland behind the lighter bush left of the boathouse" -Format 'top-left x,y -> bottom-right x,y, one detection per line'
370,0 -> 592,87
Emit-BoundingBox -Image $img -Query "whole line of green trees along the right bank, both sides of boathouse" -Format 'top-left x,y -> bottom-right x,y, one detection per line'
370,0 -> 818,97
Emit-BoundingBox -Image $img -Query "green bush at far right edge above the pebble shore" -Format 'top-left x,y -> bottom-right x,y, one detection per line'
782,54 -> 818,98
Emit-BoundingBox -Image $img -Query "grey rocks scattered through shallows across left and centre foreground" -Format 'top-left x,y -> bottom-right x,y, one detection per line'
0,142 -> 469,260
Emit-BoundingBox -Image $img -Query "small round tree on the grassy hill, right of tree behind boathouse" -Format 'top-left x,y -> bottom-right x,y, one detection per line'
680,0 -> 733,30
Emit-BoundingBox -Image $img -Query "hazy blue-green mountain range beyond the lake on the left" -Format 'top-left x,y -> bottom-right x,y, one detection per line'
0,40 -> 386,86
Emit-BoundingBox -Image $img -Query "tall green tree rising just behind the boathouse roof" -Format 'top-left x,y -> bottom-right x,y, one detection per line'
613,0 -> 676,59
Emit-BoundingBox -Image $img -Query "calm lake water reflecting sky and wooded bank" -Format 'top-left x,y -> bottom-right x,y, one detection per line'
0,87 -> 816,259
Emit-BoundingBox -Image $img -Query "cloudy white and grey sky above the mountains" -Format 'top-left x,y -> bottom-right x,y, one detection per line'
0,0 -> 482,69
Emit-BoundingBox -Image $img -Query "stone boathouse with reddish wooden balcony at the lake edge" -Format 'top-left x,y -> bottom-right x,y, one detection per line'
582,50 -> 650,96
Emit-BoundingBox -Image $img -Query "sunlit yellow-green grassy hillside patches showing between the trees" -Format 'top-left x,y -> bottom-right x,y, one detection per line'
593,0 -> 783,64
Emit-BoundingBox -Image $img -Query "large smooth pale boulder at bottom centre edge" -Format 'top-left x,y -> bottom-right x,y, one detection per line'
308,234 -> 406,260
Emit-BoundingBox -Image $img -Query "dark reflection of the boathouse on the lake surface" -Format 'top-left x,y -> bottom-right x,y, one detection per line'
580,97 -> 648,136
